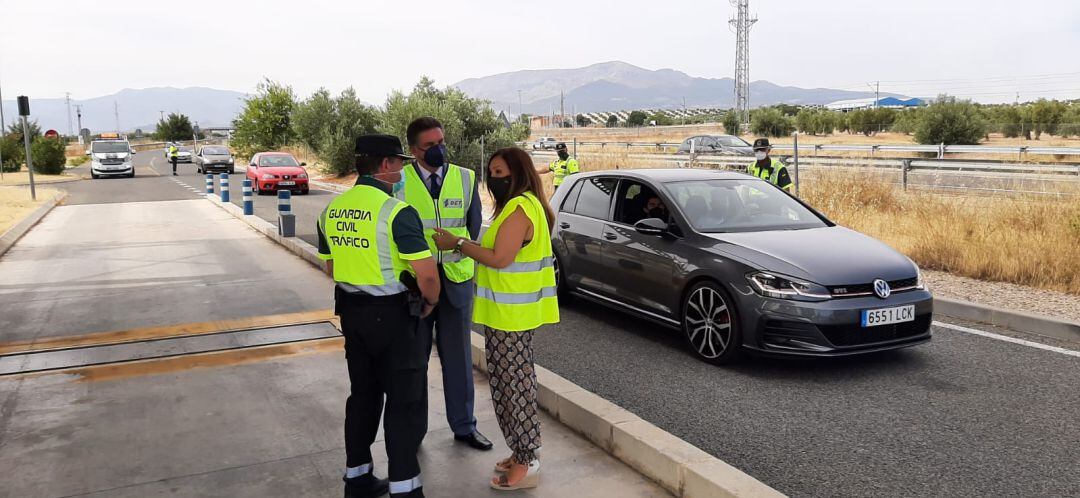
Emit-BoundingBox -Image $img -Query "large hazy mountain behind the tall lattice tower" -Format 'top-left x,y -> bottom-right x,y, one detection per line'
454,62 -> 891,115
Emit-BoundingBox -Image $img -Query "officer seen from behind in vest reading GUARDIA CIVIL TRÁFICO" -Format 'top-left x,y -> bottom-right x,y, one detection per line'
318,135 -> 440,498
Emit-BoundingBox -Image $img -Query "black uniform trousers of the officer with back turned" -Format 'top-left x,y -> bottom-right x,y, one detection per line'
335,287 -> 428,481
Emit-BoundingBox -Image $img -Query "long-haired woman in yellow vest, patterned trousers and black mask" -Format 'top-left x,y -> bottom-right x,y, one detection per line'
434,147 -> 558,489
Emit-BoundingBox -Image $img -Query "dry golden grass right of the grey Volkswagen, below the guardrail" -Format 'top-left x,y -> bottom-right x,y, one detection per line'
801,173 -> 1080,295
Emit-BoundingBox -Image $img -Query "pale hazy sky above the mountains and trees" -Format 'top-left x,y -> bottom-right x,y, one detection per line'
0,0 -> 1080,103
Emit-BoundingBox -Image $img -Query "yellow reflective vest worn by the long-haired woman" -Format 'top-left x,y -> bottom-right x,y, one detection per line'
473,192 -> 558,332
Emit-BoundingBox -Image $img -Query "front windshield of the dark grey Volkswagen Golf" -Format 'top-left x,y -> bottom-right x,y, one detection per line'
664,178 -> 828,233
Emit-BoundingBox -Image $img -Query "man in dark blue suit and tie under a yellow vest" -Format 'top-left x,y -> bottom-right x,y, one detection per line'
396,118 -> 491,450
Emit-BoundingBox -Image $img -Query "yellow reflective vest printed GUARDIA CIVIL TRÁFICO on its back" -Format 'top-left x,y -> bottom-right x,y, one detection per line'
319,185 -> 431,296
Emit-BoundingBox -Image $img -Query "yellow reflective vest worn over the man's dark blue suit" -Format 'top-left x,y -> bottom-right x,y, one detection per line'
397,160 -> 476,283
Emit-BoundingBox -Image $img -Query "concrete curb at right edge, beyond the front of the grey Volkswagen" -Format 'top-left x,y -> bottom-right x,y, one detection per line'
934,297 -> 1080,340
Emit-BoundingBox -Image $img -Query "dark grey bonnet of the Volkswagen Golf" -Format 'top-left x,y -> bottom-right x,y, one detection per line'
705,227 -> 916,285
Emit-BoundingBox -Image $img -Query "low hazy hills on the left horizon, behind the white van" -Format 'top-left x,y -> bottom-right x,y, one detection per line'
3,86 -> 247,134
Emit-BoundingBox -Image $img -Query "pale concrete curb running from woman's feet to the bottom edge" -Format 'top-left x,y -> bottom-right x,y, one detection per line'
471,334 -> 784,498
